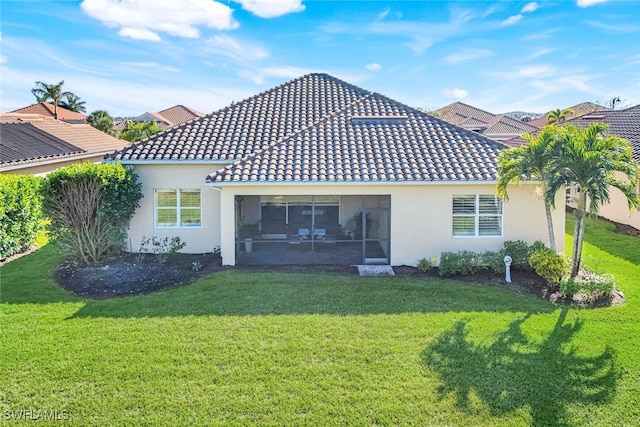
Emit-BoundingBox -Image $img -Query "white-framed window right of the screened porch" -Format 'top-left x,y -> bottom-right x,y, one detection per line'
453,194 -> 502,237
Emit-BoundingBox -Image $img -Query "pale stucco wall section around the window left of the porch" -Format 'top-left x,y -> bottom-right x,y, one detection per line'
127,164 -> 226,253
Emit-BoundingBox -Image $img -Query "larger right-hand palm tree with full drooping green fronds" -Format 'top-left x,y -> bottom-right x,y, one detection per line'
545,123 -> 640,277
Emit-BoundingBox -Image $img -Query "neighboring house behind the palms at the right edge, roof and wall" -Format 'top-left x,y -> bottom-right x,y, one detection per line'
567,105 -> 640,230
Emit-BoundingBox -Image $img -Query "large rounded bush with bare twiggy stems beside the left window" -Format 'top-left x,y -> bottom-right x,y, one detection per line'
41,163 -> 142,264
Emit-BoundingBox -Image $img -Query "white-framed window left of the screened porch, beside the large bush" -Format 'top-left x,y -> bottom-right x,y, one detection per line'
155,189 -> 202,228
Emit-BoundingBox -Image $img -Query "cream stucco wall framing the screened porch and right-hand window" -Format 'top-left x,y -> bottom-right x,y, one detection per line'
215,184 -> 564,265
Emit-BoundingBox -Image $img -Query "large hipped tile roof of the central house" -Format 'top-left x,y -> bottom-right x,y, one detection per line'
109,74 -> 505,184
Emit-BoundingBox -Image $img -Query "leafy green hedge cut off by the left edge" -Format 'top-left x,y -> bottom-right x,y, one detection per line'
0,175 -> 42,259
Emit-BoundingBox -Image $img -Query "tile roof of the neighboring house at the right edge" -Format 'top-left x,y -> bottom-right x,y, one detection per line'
567,105 -> 640,163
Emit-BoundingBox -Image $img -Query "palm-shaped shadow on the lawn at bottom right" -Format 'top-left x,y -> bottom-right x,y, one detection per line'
423,308 -> 616,426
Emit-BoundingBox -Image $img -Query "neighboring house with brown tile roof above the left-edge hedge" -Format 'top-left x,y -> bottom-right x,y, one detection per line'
0,113 -> 129,175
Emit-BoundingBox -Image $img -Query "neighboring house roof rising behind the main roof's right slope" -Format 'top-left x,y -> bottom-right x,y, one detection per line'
435,102 -> 539,146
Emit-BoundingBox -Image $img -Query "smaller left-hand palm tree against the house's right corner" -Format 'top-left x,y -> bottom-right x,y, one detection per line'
496,126 -> 558,252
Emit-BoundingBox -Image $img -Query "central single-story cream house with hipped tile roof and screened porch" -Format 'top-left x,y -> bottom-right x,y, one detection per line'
107,74 -> 564,265
